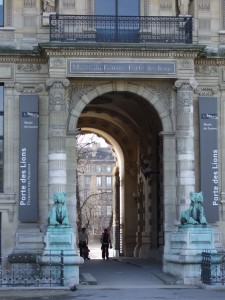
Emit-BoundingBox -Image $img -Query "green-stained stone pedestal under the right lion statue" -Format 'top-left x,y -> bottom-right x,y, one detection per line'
163,225 -> 216,284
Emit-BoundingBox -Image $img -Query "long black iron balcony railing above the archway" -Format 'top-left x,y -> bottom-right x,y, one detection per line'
50,15 -> 192,44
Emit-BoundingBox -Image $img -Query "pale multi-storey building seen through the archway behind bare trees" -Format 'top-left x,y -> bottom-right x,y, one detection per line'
78,144 -> 116,234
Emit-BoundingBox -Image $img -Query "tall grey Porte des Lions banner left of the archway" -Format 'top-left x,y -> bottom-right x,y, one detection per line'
19,95 -> 39,223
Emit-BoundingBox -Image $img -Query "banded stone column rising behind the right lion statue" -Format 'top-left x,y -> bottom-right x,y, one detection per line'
175,80 -> 197,222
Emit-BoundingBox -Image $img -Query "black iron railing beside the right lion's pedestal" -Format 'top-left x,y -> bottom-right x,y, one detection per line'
201,251 -> 225,285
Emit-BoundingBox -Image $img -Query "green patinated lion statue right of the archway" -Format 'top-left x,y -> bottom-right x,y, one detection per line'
180,192 -> 207,225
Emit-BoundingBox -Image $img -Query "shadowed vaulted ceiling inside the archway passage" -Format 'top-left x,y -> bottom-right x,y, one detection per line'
77,92 -> 162,153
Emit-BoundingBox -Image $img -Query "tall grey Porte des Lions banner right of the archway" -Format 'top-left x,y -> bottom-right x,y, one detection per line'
199,97 -> 219,222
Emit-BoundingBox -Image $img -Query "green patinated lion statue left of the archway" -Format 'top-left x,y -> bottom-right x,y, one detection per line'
48,193 -> 69,225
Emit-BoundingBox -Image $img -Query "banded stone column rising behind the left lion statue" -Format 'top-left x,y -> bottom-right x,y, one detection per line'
46,79 -> 69,204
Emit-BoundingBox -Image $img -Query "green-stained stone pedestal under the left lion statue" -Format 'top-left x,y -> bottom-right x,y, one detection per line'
39,225 -> 84,287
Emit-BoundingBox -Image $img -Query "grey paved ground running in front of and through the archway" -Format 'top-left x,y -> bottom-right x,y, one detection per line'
0,245 -> 225,300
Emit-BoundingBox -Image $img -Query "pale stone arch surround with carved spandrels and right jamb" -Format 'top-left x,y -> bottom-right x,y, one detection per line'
68,80 -> 176,260
